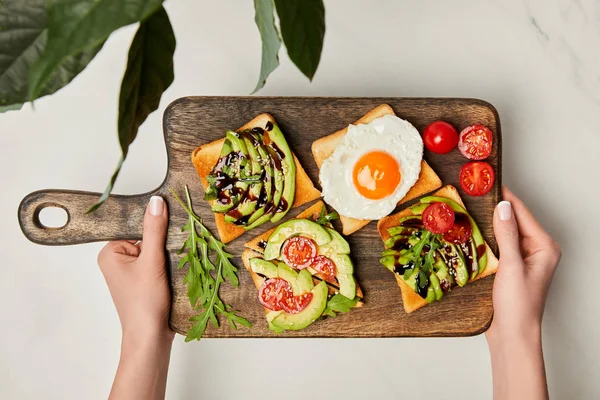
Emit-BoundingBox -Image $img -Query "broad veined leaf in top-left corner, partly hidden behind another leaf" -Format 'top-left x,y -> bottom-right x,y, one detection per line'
0,0 -> 104,112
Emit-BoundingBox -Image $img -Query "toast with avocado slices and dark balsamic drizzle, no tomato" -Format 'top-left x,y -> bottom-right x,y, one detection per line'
192,114 -> 320,243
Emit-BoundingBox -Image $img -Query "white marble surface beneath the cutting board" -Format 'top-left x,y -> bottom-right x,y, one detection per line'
0,0 -> 600,400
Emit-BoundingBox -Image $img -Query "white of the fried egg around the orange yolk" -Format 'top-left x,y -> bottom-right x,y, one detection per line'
319,115 -> 423,220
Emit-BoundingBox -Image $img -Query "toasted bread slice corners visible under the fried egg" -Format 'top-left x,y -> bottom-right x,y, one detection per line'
312,104 -> 442,235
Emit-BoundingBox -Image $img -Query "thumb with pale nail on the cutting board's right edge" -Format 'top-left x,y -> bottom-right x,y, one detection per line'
494,201 -> 522,260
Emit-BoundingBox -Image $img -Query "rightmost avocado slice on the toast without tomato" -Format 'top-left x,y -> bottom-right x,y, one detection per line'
264,124 -> 296,223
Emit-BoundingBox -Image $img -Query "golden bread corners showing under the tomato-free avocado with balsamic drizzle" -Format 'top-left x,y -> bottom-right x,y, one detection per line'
192,114 -> 321,243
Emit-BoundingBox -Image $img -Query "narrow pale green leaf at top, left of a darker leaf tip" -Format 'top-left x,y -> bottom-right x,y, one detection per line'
252,0 -> 281,93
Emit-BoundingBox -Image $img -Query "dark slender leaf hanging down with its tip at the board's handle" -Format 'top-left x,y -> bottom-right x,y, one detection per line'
89,7 -> 175,212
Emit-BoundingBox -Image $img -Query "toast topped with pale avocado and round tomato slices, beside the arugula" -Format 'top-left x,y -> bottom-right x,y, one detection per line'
242,202 -> 362,333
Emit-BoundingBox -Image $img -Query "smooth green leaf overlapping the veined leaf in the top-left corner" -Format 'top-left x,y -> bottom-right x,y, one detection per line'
28,0 -> 163,100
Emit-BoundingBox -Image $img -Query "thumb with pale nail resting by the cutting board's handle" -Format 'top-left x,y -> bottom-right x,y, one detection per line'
140,196 -> 169,261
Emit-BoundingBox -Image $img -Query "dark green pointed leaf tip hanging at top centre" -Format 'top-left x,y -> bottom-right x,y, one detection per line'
275,0 -> 325,81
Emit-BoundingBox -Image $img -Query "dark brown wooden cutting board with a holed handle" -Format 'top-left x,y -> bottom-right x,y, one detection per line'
19,97 -> 502,337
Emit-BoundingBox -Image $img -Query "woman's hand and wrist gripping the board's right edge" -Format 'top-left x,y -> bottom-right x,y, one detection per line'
486,187 -> 561,400
